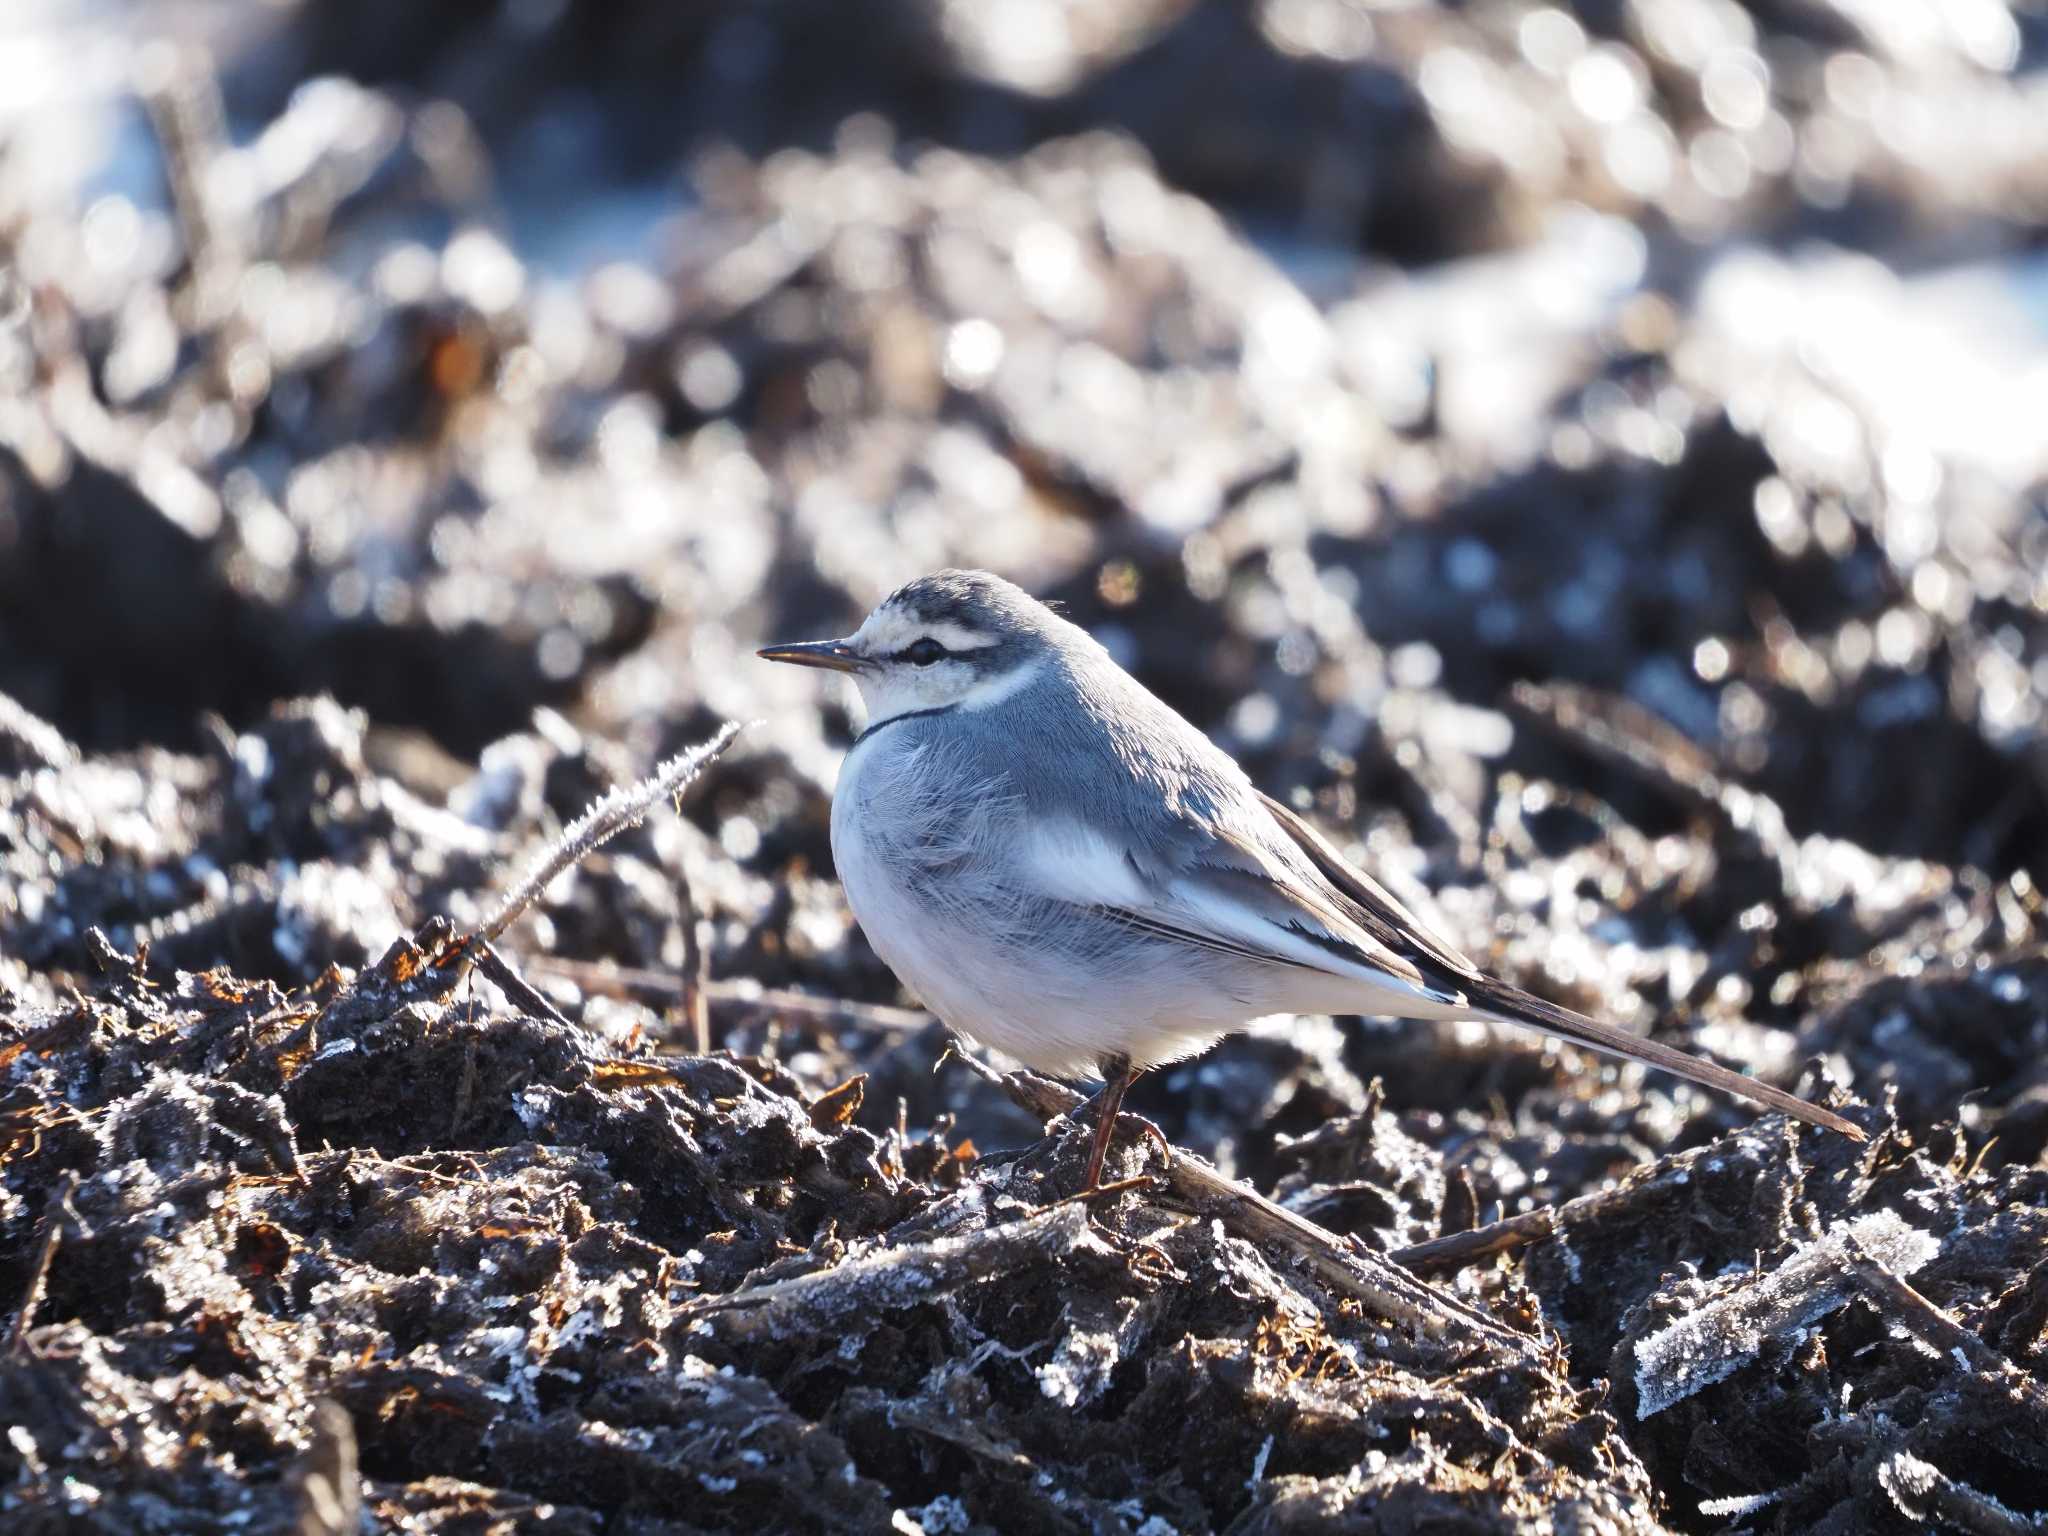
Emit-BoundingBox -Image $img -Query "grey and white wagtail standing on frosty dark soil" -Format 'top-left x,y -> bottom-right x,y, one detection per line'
758,569 -> 1864,1192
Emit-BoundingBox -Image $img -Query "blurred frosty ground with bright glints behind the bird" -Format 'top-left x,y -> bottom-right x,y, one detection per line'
0,0 -> 2048,937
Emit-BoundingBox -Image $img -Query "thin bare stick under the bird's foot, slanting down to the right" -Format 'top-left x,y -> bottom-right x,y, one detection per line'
954,1053 -> 1538,1358
